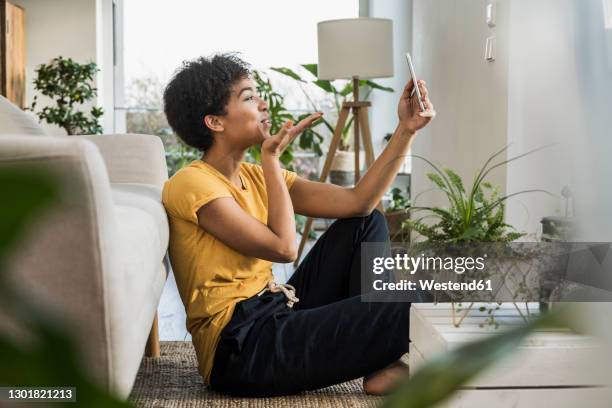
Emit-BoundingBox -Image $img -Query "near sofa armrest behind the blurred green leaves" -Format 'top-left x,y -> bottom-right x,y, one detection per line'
0,135 -> 119,386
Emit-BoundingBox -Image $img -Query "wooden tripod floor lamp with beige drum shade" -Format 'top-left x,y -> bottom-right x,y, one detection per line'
294,18 -> 393,266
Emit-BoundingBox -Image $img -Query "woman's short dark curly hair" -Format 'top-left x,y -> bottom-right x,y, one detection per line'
164,54 -> 251,151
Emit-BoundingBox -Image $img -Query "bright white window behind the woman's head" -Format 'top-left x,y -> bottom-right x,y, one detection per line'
116,0 -> 359,175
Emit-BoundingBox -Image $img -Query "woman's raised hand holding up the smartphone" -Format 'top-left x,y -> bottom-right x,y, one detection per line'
397,80 -> 436,133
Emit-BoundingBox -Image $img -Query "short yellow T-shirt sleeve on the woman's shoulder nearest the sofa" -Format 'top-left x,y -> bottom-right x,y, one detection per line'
162,169 -> 233,224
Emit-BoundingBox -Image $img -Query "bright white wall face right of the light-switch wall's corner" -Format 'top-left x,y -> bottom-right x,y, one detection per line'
506,0 -> 580,236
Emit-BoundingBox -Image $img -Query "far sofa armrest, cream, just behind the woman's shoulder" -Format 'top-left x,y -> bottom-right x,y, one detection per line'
79,133 -> 168,188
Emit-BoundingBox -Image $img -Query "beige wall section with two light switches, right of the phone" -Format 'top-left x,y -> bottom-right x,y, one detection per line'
412,0 -> 509,220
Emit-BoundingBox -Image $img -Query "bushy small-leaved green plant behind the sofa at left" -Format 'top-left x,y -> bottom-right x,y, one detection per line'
29,57 -> 104,135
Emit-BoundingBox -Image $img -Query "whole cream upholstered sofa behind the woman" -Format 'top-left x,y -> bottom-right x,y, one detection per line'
0,97 -> 169,398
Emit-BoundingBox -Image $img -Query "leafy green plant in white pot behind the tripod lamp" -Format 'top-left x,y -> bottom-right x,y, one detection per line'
271,64 -> 393,186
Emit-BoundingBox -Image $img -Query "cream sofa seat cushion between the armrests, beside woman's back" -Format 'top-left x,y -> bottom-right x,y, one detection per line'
108,184 -> 169,374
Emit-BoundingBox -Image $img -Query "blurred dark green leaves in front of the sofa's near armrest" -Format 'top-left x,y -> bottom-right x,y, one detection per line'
0,167 -> 132,407
